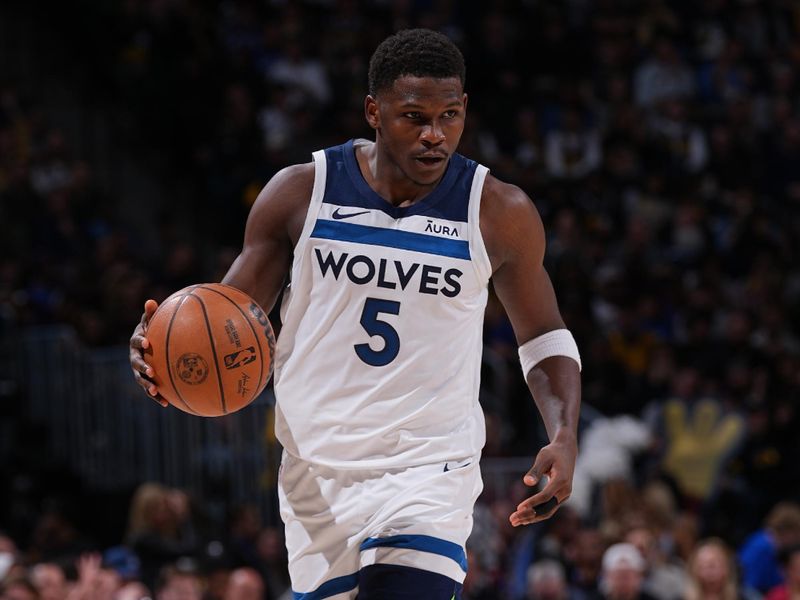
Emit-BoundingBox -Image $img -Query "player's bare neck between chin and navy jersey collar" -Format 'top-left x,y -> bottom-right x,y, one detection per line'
356,142 -> 441,207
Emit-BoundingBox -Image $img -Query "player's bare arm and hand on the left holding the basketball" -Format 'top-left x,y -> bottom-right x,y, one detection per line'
130,163 -> 314,406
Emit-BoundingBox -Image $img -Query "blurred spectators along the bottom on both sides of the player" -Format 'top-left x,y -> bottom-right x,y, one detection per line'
0,482 -> 800,600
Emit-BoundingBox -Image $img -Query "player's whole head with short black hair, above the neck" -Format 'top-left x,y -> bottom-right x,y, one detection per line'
364,29 -> 467,185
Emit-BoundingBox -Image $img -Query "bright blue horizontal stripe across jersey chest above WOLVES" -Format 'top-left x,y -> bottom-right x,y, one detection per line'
311,219 -> 470,260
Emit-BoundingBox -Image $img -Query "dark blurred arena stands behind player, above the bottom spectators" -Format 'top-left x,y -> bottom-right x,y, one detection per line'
0,0 -> 800,598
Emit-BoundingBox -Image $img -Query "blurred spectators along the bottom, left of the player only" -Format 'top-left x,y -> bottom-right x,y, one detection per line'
0,482 -> 292,600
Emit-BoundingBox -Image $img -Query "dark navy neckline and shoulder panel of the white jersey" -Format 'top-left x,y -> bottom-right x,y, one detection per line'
323,140 -> 477,223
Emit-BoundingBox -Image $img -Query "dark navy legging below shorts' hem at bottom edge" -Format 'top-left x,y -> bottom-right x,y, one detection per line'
356,565 -> 461,600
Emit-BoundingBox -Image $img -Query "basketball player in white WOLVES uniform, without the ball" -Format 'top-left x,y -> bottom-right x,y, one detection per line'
131,30 -> 580,600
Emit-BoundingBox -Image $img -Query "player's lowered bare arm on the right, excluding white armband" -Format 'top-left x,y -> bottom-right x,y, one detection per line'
481,176 -> 581,526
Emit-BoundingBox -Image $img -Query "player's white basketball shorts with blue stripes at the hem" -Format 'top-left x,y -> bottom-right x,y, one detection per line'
278,451 -> 483,600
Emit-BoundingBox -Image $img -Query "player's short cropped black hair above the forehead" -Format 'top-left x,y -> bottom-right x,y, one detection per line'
369,29 -> 466,96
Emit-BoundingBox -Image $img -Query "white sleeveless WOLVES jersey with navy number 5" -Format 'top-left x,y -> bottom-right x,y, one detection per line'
275,140 -> 491,469
